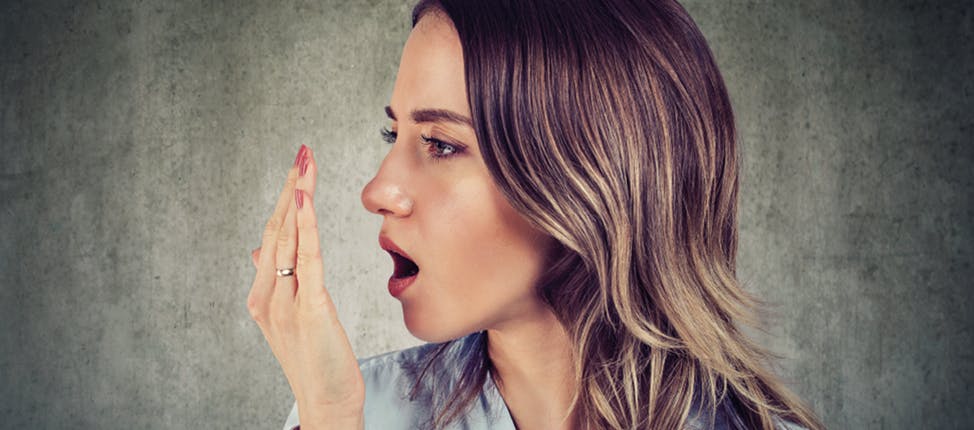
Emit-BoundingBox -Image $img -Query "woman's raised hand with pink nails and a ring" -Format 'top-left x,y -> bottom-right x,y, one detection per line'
247,145 -> 365,430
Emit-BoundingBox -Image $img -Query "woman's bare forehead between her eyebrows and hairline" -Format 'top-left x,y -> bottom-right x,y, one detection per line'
391,12 -> 470,116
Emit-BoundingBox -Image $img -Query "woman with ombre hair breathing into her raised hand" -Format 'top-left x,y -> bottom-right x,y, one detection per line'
248,0 -> 821,429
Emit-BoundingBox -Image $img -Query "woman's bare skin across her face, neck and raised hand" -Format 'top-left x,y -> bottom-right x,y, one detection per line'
248,14 -> 574,429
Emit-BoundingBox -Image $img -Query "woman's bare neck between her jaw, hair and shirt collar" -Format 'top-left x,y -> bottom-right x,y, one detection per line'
487,308 -> 575,430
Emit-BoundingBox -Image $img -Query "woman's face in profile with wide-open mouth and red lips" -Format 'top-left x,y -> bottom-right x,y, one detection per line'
362,13 -> 550,342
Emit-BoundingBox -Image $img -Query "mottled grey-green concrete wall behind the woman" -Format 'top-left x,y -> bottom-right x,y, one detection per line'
0,0 -> 974,429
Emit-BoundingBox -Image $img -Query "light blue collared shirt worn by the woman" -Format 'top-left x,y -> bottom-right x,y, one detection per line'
284,332 -> 802,430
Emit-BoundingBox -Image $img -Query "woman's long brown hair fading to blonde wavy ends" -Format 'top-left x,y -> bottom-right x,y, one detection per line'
413,0 -> 822,429
